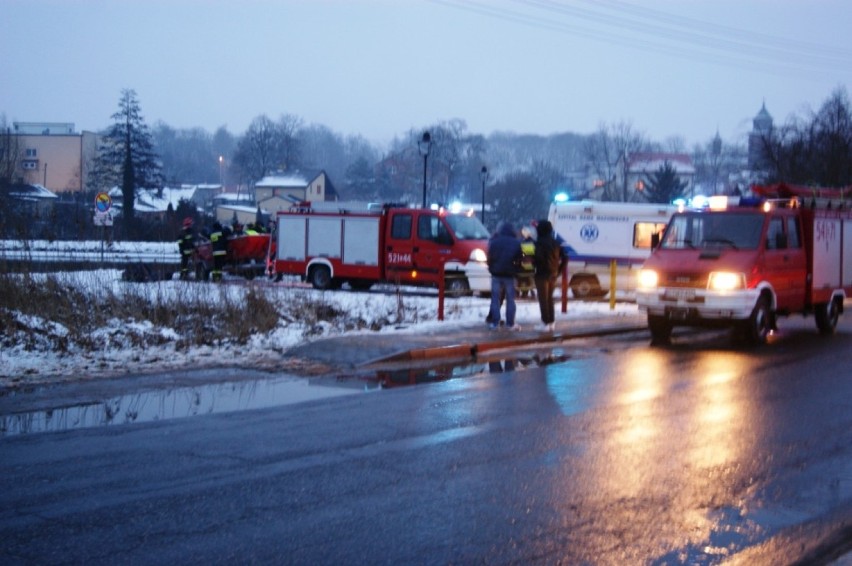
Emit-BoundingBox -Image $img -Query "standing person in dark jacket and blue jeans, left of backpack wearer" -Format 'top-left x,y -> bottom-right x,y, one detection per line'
488,222 -> 523,330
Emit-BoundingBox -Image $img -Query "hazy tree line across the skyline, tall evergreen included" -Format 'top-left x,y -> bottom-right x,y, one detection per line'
0,88 -> 852,240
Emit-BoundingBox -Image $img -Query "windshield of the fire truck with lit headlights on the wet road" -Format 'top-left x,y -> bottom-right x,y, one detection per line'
660,212 -> 764,250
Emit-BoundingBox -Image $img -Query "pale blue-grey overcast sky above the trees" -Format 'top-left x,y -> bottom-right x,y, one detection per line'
0,0 -> 852,146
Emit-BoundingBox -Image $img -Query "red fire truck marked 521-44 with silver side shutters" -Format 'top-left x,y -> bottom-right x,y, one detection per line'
275,202 -> 491,294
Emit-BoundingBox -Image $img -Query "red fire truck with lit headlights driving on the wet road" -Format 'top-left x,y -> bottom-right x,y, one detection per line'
636,184 -> 852,344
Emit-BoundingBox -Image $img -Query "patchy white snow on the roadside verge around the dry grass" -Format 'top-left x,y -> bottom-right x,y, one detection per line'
0,270 -> 636,388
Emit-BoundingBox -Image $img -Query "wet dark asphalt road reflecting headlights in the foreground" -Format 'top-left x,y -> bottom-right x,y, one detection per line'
0,313 -> 852,564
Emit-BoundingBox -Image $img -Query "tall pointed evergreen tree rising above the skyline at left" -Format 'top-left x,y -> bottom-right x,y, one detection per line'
93,89 -> 162,235
